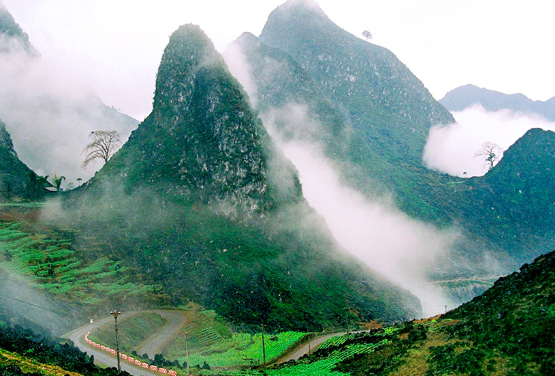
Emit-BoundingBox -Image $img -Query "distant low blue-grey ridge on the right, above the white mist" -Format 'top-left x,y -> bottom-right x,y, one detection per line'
439,85 -> 555,121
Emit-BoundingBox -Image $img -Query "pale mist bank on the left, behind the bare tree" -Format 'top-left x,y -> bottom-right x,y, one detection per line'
0,38 -> 137,186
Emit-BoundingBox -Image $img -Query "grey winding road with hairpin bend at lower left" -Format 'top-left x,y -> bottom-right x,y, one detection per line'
64,310 -> 187,376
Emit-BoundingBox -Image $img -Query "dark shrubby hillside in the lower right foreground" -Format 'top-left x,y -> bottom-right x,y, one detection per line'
280,248 -> 555,376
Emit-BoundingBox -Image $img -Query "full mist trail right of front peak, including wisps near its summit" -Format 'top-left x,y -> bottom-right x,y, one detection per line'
224,45 -> 460,316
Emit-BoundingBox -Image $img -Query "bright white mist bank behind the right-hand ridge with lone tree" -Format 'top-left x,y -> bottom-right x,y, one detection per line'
424,105 -> 555,177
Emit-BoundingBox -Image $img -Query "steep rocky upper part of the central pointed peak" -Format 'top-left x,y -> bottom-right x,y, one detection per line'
99,28 -> 301,213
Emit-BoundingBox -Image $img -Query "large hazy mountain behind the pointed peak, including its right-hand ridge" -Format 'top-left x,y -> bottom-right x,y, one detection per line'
225,0 -> 553,302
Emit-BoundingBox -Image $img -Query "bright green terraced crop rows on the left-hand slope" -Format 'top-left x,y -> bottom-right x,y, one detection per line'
0,222 -> 159,305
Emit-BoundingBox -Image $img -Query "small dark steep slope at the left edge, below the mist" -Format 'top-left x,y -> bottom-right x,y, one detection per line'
0,120 -> 37,201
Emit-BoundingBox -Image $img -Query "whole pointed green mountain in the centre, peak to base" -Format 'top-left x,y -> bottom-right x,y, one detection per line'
62,25 -> 420,329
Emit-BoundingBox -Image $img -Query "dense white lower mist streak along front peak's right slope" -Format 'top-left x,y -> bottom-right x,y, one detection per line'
265,122 -> 459,316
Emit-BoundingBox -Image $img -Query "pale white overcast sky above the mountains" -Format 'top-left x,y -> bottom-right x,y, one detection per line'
2,0 -> 555,120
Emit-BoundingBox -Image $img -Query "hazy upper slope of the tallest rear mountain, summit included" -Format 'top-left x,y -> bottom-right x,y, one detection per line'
259,0 -> 453,173
